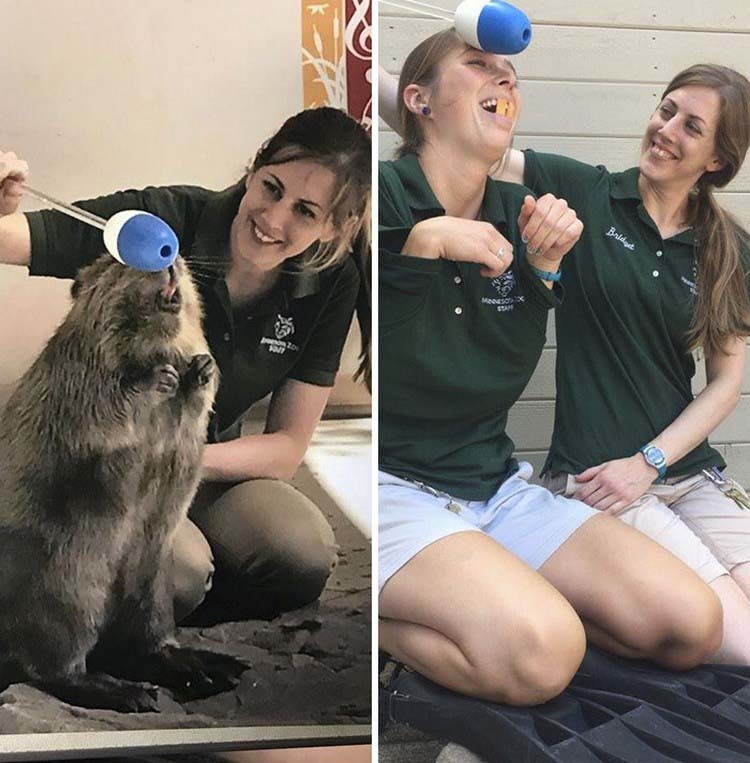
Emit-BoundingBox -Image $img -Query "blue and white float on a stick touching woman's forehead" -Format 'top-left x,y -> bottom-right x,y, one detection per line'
380,0 -> 531,55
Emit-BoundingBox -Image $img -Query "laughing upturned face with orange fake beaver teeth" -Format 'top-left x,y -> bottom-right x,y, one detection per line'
425,48 -> 521,161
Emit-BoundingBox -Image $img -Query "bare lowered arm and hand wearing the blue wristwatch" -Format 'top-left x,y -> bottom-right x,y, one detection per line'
575,338 -> 745,514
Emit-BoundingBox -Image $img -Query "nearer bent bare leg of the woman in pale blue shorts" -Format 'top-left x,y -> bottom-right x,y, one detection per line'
380,532 -> 585,705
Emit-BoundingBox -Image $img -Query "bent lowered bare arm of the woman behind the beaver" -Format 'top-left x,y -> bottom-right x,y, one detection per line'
202,379 -> 331,482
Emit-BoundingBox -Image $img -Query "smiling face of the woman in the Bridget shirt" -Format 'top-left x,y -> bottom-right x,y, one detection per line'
640,85 -> 724,187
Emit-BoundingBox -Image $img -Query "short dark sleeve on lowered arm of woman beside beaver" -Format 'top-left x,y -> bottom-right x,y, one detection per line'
287,257 -> 360,387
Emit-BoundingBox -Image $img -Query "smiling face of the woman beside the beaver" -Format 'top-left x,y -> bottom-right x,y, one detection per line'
231,159 -> 336,270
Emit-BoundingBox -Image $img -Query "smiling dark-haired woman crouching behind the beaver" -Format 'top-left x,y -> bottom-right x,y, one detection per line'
0,108 -> 371,622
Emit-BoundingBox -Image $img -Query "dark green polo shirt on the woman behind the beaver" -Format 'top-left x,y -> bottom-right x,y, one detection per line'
27,183 -> 359,441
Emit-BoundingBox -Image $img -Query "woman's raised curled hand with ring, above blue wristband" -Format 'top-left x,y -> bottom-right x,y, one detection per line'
518,193 -> 583,271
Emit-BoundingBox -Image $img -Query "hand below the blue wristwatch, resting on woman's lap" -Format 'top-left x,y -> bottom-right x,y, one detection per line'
573,453 -> 658,516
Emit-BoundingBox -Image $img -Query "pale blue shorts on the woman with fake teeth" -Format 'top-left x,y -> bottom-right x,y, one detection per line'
378,462 -> 599,590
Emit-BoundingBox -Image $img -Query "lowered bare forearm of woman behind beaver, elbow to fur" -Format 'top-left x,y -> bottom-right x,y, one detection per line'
201,432 -> 305,482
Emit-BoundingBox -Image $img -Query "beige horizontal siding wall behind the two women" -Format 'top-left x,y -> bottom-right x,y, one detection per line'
379,0 -> 750,485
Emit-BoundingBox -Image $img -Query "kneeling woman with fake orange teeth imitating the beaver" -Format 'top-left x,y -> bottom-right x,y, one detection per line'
379,31 -> 721,704
